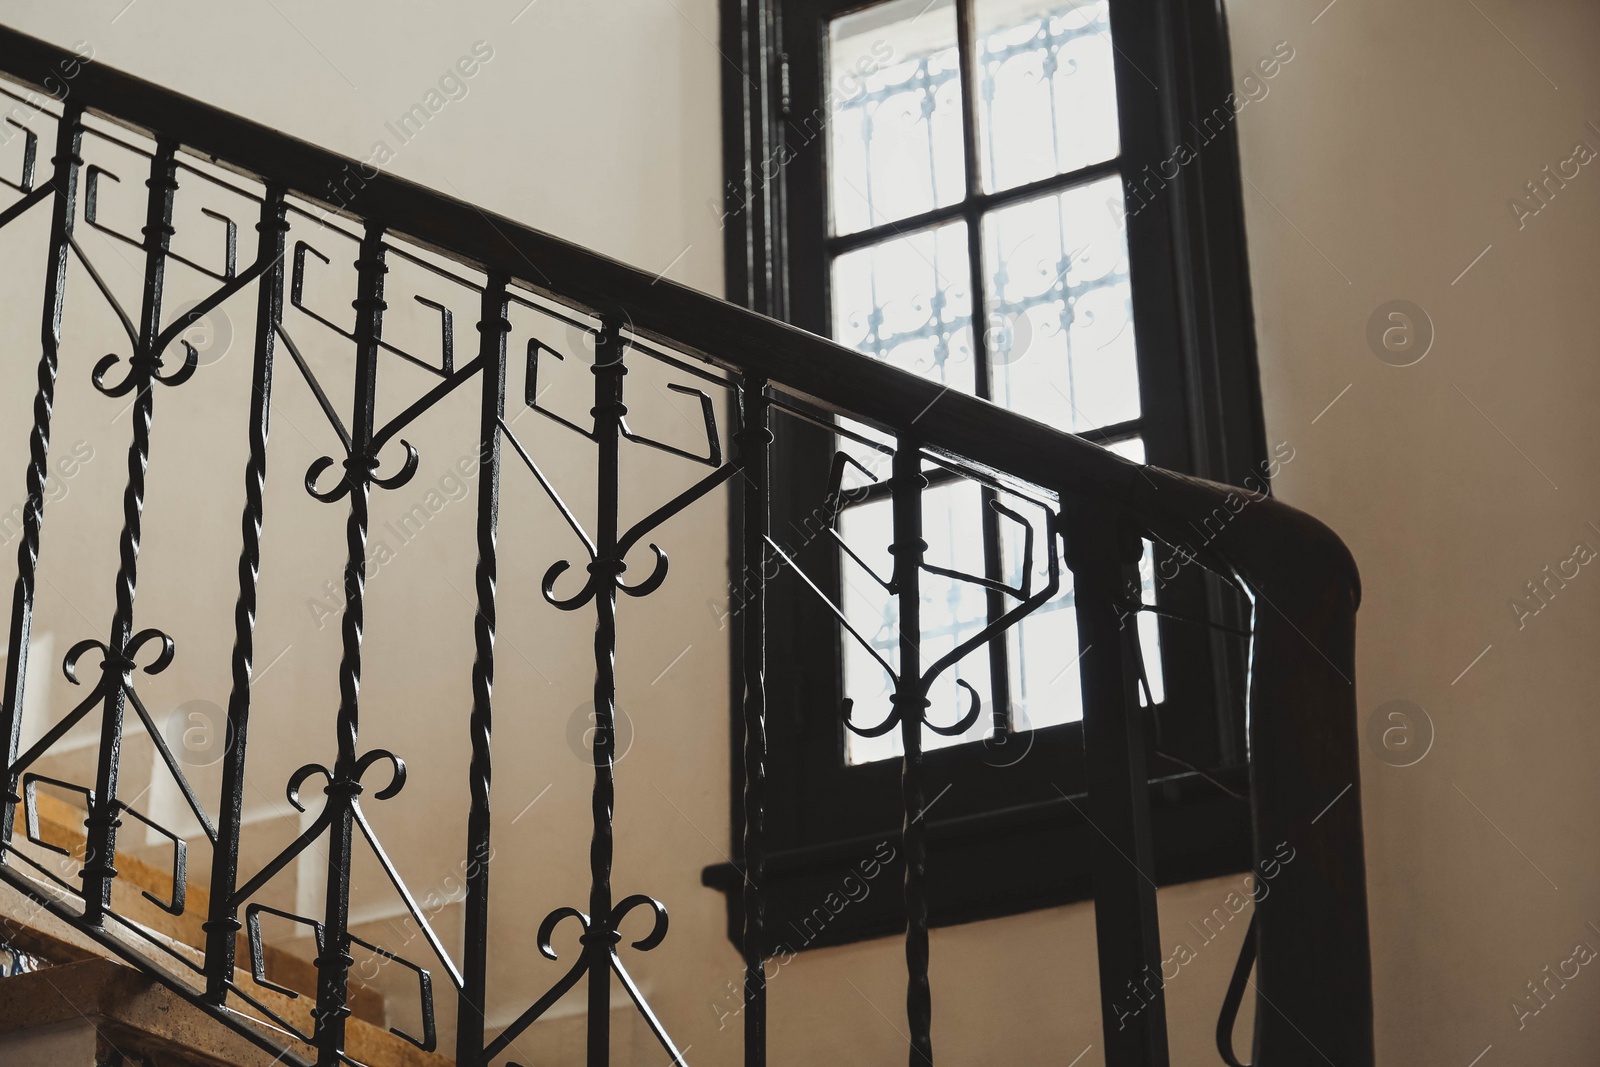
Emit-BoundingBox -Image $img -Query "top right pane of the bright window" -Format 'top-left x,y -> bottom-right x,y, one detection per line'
974,0 -> 1118,190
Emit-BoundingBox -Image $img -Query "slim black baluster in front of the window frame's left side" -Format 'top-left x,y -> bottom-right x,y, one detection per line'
738,378 -> 773,1067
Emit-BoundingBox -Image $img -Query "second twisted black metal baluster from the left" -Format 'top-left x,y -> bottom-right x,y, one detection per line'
80,138 -> 178,926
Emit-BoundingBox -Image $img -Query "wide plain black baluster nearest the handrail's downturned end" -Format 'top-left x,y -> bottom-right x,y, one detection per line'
1062,499 -> 1166,1067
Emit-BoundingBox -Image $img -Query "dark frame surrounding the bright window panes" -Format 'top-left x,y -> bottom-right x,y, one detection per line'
706,0 -> 1267,949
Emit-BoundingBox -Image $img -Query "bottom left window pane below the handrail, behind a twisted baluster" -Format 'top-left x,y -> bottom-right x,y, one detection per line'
840,482 -> 994,765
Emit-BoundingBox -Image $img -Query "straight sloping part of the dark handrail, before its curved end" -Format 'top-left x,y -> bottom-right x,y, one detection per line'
0,27 -> 1138,496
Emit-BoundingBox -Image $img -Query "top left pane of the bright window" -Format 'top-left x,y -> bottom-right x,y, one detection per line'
832,0 -> 966,234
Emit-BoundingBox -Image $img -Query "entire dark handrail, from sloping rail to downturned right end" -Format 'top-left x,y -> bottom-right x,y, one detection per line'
0,27 -> 1373,1067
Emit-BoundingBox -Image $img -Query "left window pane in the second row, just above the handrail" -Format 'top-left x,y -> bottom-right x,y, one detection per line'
834,222 -> 973,392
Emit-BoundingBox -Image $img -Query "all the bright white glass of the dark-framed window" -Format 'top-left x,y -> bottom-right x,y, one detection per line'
825,0 -> 1163,763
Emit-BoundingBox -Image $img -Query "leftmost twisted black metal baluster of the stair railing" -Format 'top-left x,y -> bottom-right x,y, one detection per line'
0,106 -> 83,859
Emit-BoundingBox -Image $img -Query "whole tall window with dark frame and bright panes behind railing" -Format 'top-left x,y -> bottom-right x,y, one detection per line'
707,0 -> 1266,941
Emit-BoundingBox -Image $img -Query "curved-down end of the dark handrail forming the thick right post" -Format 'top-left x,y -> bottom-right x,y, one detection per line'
1126,467 -> 1373,1067
